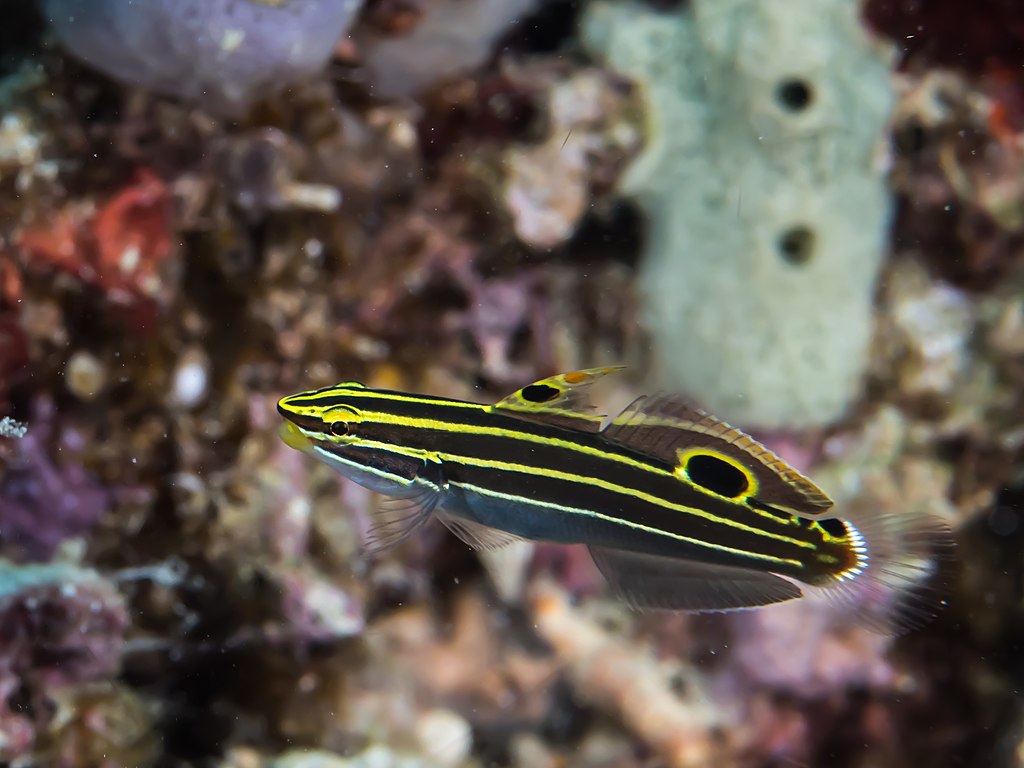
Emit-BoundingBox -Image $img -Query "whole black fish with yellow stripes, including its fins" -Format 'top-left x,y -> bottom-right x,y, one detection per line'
278,366 -> 951,634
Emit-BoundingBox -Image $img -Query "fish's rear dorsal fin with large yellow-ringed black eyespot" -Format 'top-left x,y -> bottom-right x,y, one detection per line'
601,394 -> 833,515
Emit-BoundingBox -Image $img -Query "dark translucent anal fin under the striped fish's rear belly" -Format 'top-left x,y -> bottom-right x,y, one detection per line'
589,546 -> 804,611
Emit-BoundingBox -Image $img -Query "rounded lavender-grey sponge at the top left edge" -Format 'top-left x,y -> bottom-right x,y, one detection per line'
42,0 -> 362,115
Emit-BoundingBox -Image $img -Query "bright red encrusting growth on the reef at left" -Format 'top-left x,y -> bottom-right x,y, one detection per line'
18,170 -> 171,331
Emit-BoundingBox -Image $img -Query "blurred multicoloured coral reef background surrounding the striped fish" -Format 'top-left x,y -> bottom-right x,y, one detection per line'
0,0 -> 1024,768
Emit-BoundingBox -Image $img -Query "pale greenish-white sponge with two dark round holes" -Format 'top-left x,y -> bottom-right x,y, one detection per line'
584,0 -> 894,428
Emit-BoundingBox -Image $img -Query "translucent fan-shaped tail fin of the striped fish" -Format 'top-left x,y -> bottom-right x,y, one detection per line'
806,501 -> 953,635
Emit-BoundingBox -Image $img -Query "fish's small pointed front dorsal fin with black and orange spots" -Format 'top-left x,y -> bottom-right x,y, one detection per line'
490,366 -> 625,432
